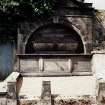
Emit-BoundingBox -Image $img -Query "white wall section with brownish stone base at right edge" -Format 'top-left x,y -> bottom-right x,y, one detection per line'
92,53 -> 105,105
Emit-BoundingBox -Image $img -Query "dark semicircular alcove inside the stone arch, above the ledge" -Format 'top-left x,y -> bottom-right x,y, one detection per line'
25,24 -> 84,54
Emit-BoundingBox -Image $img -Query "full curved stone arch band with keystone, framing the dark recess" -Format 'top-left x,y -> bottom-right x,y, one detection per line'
18,17 -> 90,54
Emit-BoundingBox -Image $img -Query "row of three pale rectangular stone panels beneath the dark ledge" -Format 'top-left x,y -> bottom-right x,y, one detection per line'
20,55 -> 92,75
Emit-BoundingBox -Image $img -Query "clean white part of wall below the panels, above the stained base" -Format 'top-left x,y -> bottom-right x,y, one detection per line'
19,76 -> 97,100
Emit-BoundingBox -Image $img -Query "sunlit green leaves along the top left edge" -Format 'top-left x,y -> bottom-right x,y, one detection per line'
0,0 -> 56,15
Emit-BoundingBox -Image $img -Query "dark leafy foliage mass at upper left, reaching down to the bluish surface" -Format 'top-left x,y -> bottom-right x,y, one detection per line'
0,0 -> 56,42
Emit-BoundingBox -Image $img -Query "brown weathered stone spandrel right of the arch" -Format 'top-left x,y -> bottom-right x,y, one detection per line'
67,17 -> 93,53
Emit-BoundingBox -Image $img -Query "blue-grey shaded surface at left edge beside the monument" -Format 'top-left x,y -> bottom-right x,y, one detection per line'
0,42 -> 14,80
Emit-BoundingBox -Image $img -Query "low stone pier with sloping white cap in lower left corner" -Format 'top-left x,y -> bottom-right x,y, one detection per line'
0,72 -> 19,105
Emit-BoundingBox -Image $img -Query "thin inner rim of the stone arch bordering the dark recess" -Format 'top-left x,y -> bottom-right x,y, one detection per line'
25,21 -> 86,54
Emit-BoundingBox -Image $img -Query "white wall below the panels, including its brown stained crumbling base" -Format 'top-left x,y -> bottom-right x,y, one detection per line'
19,76 -> 98,105
